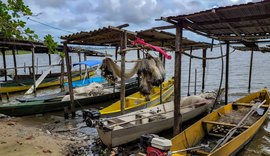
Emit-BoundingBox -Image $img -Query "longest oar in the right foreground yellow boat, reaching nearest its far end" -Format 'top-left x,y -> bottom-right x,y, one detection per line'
211,100 -> 266,152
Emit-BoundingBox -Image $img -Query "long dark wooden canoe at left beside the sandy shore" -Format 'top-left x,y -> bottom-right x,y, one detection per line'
0,78 -> 138,116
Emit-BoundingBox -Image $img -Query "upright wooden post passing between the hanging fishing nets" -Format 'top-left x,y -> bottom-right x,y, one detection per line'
120,31 -> 127,114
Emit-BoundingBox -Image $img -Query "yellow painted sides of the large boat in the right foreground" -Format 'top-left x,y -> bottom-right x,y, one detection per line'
171,89 -> 270,156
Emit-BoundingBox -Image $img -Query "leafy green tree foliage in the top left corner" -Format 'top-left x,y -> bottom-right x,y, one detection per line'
0,0 -> 38,40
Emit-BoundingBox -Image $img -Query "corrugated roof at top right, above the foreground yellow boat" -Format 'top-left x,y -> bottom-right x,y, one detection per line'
166,1 -> 270,40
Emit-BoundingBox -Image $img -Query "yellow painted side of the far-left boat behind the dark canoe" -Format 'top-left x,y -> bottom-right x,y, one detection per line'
0,71 -> 95,93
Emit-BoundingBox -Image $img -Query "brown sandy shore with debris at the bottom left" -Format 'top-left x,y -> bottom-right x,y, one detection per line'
0,113 -> 95,156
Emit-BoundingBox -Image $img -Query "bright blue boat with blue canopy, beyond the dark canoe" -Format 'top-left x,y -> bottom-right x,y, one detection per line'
64,60 -> 106,88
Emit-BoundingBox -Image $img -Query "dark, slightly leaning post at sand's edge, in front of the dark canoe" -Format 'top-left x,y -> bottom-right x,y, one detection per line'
63,42 -> 76,118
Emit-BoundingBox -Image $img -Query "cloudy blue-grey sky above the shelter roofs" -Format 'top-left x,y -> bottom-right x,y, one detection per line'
24,0 -> 258,41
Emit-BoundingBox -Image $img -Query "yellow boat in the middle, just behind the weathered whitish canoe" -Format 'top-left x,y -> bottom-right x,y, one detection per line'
99,78 -> 174,117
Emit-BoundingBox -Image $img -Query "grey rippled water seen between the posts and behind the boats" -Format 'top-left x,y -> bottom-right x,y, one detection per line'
0,45 -> 270,155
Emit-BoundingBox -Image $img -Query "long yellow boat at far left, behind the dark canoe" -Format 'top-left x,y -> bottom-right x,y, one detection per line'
0,71 -> 94,93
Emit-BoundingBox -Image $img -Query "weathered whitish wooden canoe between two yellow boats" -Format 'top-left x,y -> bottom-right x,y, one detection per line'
97,96 -> 213,147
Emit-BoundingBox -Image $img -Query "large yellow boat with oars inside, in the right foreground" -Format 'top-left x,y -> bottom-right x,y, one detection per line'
171,89 -> 270,156
